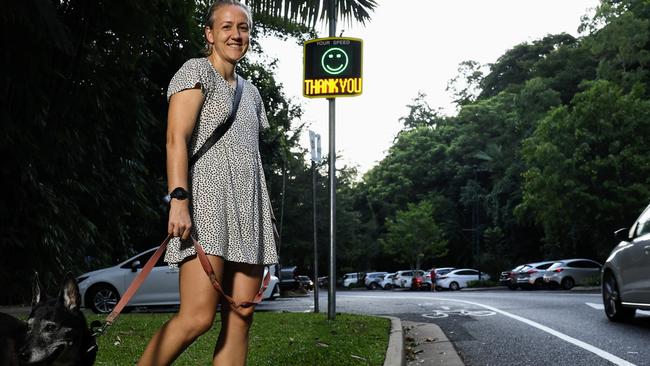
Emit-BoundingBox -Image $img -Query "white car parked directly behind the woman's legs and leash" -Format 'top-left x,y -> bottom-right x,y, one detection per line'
77,248 -> 280,314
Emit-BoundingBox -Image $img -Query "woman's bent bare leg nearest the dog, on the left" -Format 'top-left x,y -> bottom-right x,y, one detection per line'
138,255 -> 224,366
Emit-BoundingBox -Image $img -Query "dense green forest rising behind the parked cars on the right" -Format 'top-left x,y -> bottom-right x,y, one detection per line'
346,0 -> 650,274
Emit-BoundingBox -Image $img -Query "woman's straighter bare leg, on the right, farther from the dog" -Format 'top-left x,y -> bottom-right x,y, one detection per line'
212,262 -> 264,366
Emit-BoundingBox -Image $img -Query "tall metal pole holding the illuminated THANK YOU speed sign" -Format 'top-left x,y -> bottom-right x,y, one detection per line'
327,0 -> 337,320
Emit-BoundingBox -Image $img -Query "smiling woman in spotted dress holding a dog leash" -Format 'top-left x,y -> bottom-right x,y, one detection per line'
138,0 -> 277,366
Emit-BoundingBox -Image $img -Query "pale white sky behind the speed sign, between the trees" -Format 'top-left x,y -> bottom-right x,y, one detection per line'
260,0 -> 598,173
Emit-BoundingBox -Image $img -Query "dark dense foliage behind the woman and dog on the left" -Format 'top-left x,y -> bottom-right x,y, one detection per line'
0,0 -> 376,304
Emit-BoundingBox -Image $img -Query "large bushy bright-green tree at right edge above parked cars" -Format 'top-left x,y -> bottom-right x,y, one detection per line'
518,80 -> 650,258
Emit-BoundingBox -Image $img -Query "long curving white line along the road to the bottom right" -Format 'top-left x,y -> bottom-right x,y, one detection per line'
345,295 -> 636,366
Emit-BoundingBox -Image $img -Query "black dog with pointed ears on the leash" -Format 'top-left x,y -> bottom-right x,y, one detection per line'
0,274 -> 97,366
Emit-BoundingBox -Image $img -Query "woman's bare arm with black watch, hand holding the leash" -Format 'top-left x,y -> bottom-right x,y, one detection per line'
167,88 -> 204,239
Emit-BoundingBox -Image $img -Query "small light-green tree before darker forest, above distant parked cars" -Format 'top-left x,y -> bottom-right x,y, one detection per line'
381,201 -> 447,269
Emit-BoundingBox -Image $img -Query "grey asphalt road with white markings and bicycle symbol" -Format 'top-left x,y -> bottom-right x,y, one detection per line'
258,290 -> 650,366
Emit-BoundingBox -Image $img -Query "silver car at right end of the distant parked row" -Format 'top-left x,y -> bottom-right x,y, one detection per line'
544,258 -> 602,290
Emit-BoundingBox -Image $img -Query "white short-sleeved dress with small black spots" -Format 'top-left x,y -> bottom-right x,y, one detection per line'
165,58 -> 278,266
